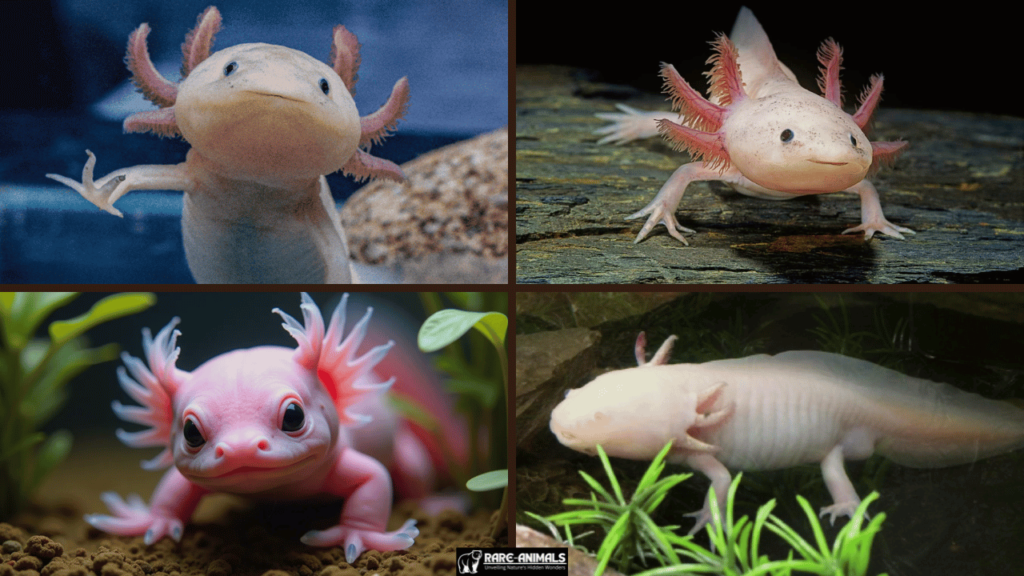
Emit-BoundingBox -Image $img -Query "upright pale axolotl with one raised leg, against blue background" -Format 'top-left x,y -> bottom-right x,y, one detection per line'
47,6 -> 409,283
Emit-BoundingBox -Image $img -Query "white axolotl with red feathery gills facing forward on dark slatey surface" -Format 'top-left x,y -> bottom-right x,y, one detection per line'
597,7 -> 914,245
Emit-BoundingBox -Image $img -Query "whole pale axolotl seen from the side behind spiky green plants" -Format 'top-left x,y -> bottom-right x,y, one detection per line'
551,333 -> 1024,534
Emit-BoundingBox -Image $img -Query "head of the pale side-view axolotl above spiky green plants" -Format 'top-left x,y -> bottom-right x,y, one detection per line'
551,365 -> 731,460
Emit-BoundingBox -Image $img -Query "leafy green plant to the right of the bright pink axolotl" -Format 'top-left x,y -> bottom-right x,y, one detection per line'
418,292 -> 508,536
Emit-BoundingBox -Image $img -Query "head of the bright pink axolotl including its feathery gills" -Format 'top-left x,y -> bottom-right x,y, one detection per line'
114,294 -> 394,493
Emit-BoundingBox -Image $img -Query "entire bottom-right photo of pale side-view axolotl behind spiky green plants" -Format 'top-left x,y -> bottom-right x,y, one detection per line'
515,292 -> 1024,576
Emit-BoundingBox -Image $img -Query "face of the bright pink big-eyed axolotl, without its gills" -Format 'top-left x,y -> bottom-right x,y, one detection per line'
170,346 -> 340,493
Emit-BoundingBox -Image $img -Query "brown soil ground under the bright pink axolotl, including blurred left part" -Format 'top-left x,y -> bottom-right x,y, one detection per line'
0,439 -> 507,576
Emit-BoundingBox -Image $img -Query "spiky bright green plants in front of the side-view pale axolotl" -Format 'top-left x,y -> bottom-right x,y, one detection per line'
544,442 -> 886,576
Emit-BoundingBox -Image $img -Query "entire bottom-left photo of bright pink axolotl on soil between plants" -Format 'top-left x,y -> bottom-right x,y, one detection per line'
0,292 -> 509,576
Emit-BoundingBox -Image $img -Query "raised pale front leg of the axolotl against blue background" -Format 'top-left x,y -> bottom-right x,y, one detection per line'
46,150 -> 195,217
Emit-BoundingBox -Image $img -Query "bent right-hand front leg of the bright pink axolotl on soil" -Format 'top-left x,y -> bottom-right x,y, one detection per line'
302,448 -> 420,564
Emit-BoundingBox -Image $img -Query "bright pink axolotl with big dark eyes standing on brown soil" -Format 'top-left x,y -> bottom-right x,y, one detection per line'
85,294 -> 459,563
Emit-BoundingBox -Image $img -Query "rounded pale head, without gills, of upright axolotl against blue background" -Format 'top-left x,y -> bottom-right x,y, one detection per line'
174,43 -> 361,182
